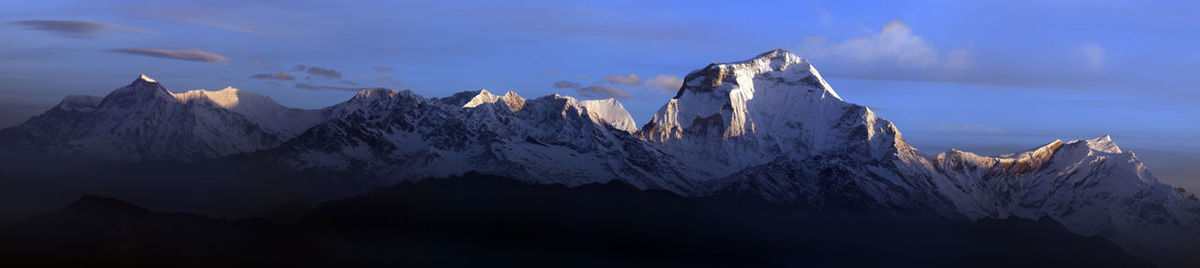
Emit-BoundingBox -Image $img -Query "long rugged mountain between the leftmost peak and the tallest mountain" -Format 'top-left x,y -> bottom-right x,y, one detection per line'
263,89 -> 692,191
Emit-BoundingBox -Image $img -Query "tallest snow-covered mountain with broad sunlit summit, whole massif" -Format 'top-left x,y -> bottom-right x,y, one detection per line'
636,49 -> 956,216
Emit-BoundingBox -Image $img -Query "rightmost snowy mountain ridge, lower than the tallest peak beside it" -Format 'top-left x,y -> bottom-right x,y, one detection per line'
929,136 -> 1200,263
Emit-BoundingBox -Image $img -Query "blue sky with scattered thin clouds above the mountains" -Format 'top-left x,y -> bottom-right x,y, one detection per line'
0,0 -> 1200,189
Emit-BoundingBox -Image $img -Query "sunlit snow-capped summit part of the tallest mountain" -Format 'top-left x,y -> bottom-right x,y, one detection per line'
641,49 -> 848,141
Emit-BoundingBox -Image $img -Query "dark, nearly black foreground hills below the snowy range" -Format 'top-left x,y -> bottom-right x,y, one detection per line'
0,174 -> 1151,267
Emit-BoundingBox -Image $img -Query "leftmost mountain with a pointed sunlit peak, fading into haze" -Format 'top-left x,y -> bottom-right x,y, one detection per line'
0,75 -> 329,162
